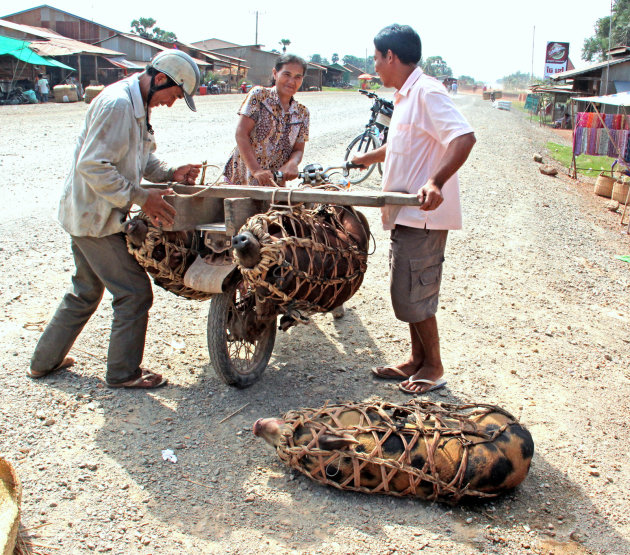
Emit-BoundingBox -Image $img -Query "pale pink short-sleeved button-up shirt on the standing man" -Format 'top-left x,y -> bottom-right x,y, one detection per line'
381,68 -> 473,229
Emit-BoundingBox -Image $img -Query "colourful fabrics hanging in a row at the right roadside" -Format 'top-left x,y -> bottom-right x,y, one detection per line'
573,112 -> 630,161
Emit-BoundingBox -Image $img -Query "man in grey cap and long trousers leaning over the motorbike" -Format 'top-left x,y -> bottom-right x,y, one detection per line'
27,50 -> 200,389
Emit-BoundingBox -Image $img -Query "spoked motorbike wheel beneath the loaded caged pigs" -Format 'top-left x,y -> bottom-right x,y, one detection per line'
208,280 -> 276,388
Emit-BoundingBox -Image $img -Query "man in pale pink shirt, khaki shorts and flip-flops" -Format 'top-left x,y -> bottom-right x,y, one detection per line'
352,24 -> 476,394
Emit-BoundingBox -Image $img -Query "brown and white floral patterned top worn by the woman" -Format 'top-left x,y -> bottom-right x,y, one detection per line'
223,87 -> 310,186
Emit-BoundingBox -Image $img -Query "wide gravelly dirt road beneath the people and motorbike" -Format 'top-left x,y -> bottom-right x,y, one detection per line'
0,89 -> 630,554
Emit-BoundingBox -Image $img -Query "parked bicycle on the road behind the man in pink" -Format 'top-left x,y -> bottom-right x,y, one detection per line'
344,89 -> 394,184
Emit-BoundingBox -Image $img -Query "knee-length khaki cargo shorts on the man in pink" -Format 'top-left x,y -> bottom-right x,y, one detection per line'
389,225 -> 448,322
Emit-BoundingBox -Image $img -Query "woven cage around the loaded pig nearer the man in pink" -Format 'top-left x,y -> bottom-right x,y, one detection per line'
239,205 -> 367,314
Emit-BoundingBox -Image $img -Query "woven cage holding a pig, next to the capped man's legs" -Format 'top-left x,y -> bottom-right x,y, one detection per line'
127,217 -> 212,301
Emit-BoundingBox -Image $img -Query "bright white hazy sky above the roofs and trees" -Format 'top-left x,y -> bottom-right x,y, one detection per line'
0,0 -> 610,83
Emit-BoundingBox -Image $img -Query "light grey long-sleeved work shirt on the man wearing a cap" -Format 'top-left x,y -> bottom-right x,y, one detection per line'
59,75 -> 174,237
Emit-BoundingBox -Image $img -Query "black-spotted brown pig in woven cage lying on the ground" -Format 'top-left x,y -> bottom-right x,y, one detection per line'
254,400 -> 534,503
